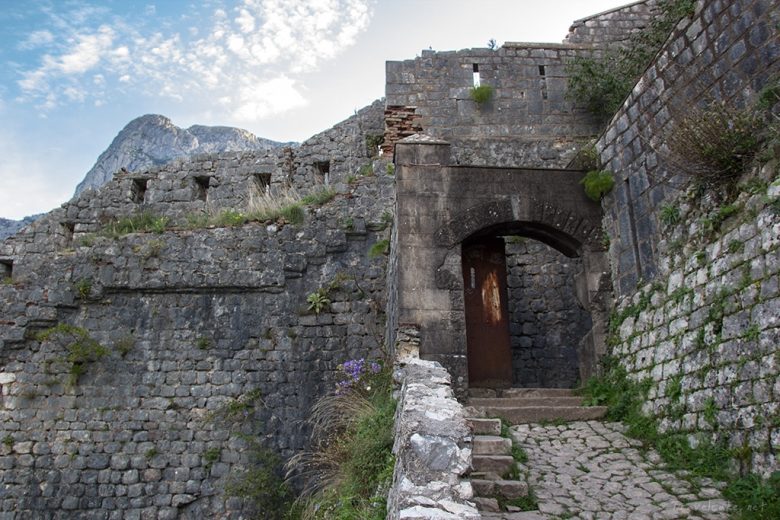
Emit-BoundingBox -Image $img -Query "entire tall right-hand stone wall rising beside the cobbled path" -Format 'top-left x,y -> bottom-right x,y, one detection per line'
597,0 -> 780,473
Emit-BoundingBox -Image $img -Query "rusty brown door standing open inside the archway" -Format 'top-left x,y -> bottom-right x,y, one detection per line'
463,237 -> 512,388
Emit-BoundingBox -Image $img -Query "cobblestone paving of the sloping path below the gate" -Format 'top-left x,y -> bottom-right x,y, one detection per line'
512,421 -> 729,520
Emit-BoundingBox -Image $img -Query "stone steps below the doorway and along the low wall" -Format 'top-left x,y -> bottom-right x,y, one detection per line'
466,388 -> 607,520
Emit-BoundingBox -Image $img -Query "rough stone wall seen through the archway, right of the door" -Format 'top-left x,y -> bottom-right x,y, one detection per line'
506,237 -> 591,388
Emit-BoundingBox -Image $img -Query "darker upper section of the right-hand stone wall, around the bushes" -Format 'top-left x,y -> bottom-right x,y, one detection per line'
597,0 -> 780,296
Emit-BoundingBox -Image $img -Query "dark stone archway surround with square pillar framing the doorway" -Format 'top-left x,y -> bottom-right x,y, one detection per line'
393,136 -> 609,394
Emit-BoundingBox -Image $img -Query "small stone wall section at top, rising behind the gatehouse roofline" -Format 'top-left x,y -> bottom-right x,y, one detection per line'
564,0 -> 658,46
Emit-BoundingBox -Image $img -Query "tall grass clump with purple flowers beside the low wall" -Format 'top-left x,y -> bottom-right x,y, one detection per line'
287,360 -> 395,520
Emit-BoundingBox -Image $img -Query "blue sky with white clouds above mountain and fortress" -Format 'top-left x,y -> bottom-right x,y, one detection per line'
0,0 -> 627,218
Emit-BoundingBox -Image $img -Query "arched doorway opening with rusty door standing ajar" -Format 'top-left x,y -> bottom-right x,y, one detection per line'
461,222 -> 592,388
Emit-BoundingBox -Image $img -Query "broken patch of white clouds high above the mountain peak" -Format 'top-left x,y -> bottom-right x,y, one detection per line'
18,0 -> 373,122
